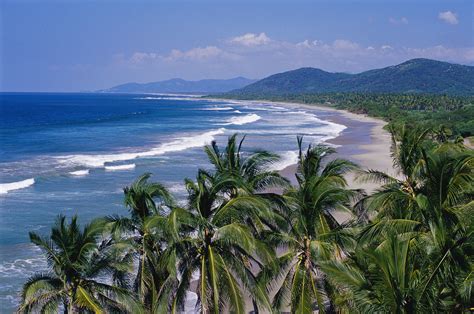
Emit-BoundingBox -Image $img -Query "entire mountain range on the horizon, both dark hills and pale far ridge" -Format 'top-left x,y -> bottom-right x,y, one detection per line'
99,59 -> 474,98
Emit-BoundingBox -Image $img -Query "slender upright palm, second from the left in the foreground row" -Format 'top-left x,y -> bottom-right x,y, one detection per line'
108,173 -> 173,311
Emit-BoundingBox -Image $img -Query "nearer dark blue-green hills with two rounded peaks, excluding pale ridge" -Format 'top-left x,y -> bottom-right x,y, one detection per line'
228,59 -> 474,98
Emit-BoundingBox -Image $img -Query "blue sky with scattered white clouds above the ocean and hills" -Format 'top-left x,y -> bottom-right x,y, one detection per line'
0,0 -> 474,92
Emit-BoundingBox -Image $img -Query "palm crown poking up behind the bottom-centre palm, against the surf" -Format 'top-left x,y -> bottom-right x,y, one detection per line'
204,134 -> 288,197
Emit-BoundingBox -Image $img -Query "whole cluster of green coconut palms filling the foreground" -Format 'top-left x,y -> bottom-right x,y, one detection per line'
19,128 -> 474,313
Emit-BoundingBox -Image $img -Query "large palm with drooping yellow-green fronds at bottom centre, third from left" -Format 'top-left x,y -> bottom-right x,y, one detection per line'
167,171 -> 272,313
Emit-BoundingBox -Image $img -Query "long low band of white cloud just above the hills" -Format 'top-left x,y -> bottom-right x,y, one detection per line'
115,33 -> 474,81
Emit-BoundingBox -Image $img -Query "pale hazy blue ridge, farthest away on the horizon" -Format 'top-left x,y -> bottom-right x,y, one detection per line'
98,77 -> 256,93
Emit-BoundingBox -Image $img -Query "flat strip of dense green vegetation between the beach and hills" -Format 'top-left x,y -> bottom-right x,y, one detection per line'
216,93 -> 474,137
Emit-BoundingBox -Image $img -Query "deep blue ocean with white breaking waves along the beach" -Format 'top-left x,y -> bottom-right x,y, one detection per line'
0,93 -> 345,313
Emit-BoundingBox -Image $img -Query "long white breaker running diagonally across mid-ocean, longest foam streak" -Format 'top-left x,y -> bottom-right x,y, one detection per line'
56,128 -> 225,168
